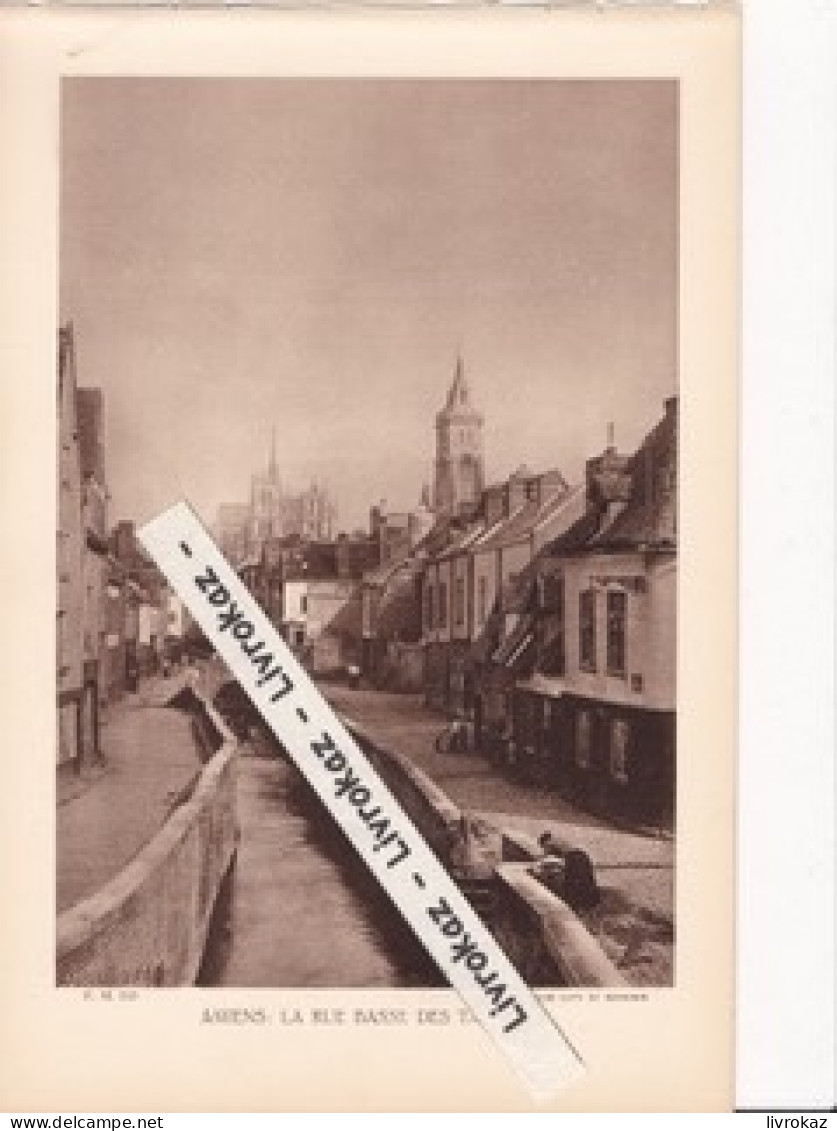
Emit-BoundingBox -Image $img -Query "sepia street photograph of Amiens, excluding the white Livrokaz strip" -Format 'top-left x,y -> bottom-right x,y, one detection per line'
57,78 -> 679,988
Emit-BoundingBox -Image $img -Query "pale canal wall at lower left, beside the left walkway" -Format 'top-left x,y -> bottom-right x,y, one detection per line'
55,697 -> 238,986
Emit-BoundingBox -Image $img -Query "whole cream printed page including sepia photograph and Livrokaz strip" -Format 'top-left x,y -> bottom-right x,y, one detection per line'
0,5 -> 741,1112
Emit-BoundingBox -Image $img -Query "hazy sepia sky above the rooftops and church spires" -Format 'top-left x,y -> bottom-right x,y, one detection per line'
61,79 -> 678,529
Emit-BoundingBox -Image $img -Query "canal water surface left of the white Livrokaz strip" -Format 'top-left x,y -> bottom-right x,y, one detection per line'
198,744 -> 443,987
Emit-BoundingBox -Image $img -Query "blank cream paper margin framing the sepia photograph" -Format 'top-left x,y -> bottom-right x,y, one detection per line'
0,10 -> 740,1112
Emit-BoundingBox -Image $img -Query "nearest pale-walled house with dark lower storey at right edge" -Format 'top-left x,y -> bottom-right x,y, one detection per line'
512,397 -> 678,824
